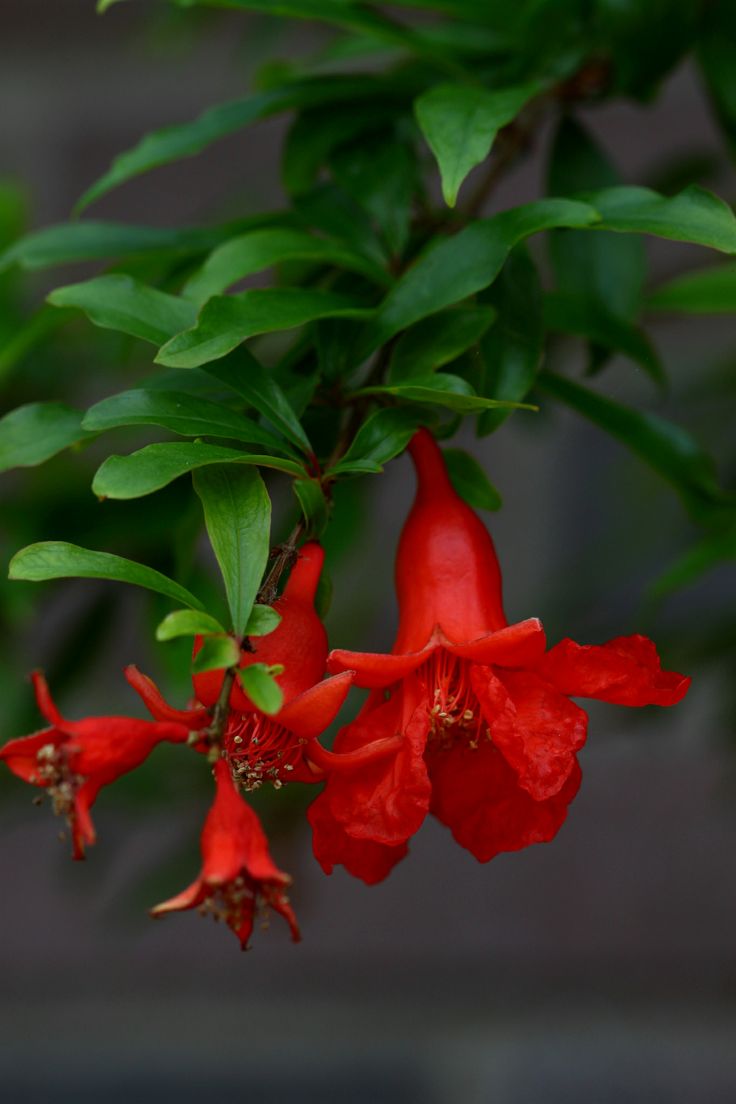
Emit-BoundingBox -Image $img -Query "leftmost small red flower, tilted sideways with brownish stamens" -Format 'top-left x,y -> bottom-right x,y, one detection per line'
0,671 -> 189,859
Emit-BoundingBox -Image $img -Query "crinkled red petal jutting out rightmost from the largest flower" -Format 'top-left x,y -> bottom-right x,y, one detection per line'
538,635 -> 691,705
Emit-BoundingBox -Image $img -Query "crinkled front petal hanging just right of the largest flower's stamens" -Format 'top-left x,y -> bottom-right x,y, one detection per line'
470,667 -> 588,802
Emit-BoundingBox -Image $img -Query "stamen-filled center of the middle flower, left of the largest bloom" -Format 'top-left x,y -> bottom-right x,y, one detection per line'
225,713 -> 306,792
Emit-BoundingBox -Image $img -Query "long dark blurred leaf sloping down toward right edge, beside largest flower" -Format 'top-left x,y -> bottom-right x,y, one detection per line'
540,372 -> 736,514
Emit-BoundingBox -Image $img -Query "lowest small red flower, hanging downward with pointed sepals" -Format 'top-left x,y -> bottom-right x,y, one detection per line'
151,758 -> 300,951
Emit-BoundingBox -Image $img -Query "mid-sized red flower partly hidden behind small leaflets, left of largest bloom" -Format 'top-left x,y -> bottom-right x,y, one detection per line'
126,543 -> 375,790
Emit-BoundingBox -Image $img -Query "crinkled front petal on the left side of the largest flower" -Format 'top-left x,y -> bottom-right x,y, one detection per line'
322,680 -> 430,847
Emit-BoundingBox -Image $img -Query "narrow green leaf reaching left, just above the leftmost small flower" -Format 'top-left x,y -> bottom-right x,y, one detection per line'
8,541 -> 204,609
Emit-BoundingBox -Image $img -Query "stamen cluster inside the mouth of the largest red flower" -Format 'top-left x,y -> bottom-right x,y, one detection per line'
417,648 -> 491,749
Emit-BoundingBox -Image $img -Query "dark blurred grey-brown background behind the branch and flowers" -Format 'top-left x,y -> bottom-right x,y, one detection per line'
0,0 -> 736,1104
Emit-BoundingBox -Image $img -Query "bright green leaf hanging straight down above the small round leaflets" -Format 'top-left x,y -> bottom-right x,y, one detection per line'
194,465 -> 270,636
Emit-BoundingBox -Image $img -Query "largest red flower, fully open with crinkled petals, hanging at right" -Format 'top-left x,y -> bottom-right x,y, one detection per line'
309,429 -> 690,882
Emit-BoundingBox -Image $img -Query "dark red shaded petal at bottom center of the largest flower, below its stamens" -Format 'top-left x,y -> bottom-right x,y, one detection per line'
427,742 -> 580,862
